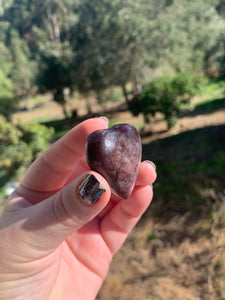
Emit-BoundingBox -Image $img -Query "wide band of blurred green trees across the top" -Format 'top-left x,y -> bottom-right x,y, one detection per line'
0,0 -> 225,106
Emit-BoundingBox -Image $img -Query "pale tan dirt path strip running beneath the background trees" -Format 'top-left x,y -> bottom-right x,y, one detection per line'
13,99 -> 225,141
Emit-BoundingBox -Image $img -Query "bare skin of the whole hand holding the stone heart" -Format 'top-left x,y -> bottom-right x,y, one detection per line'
0,118 -> 156,300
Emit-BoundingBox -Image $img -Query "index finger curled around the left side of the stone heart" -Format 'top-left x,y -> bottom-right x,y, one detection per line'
17,118 -> 108,203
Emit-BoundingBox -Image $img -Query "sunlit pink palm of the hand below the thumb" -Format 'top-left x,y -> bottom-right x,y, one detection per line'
18,218 -> 112,300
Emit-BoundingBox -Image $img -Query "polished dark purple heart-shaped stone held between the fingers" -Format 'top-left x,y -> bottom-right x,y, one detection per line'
86,124 -> 142,199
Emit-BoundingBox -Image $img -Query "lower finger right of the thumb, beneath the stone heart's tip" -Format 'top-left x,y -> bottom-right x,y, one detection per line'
100,185 -> 153,254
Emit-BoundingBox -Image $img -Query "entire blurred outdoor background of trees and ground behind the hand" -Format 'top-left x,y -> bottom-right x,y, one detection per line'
0,0 -> 225,300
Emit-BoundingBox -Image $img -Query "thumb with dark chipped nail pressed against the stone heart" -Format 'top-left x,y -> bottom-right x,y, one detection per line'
16,171 -> 111,254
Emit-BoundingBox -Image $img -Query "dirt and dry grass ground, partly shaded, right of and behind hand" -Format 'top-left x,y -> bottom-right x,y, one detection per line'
4,95 -> 225,300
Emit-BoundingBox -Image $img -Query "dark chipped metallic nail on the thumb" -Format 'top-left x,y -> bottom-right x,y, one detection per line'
78,174 -> 105,205
